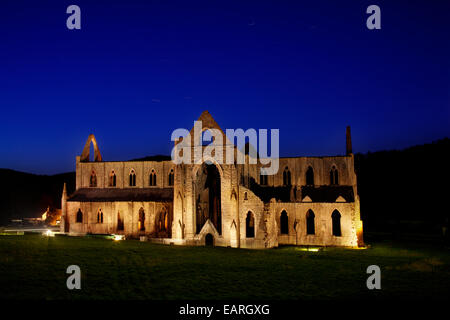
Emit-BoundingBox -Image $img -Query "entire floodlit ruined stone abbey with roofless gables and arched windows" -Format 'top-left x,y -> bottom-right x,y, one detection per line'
61,111 -> 363,248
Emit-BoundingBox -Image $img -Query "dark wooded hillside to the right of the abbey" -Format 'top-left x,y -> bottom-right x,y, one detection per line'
355,138 -> 450,234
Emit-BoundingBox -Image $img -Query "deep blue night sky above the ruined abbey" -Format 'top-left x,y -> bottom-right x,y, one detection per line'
0,0 -> 450,174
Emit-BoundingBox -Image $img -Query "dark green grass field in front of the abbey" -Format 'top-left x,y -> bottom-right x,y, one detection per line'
0,235 -> 450,300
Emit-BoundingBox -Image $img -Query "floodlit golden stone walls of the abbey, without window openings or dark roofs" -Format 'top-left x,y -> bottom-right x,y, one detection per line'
61,112 -> 362,248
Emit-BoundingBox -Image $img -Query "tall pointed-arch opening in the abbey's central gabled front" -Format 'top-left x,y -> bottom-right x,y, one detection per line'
195,163 -> 222,235
